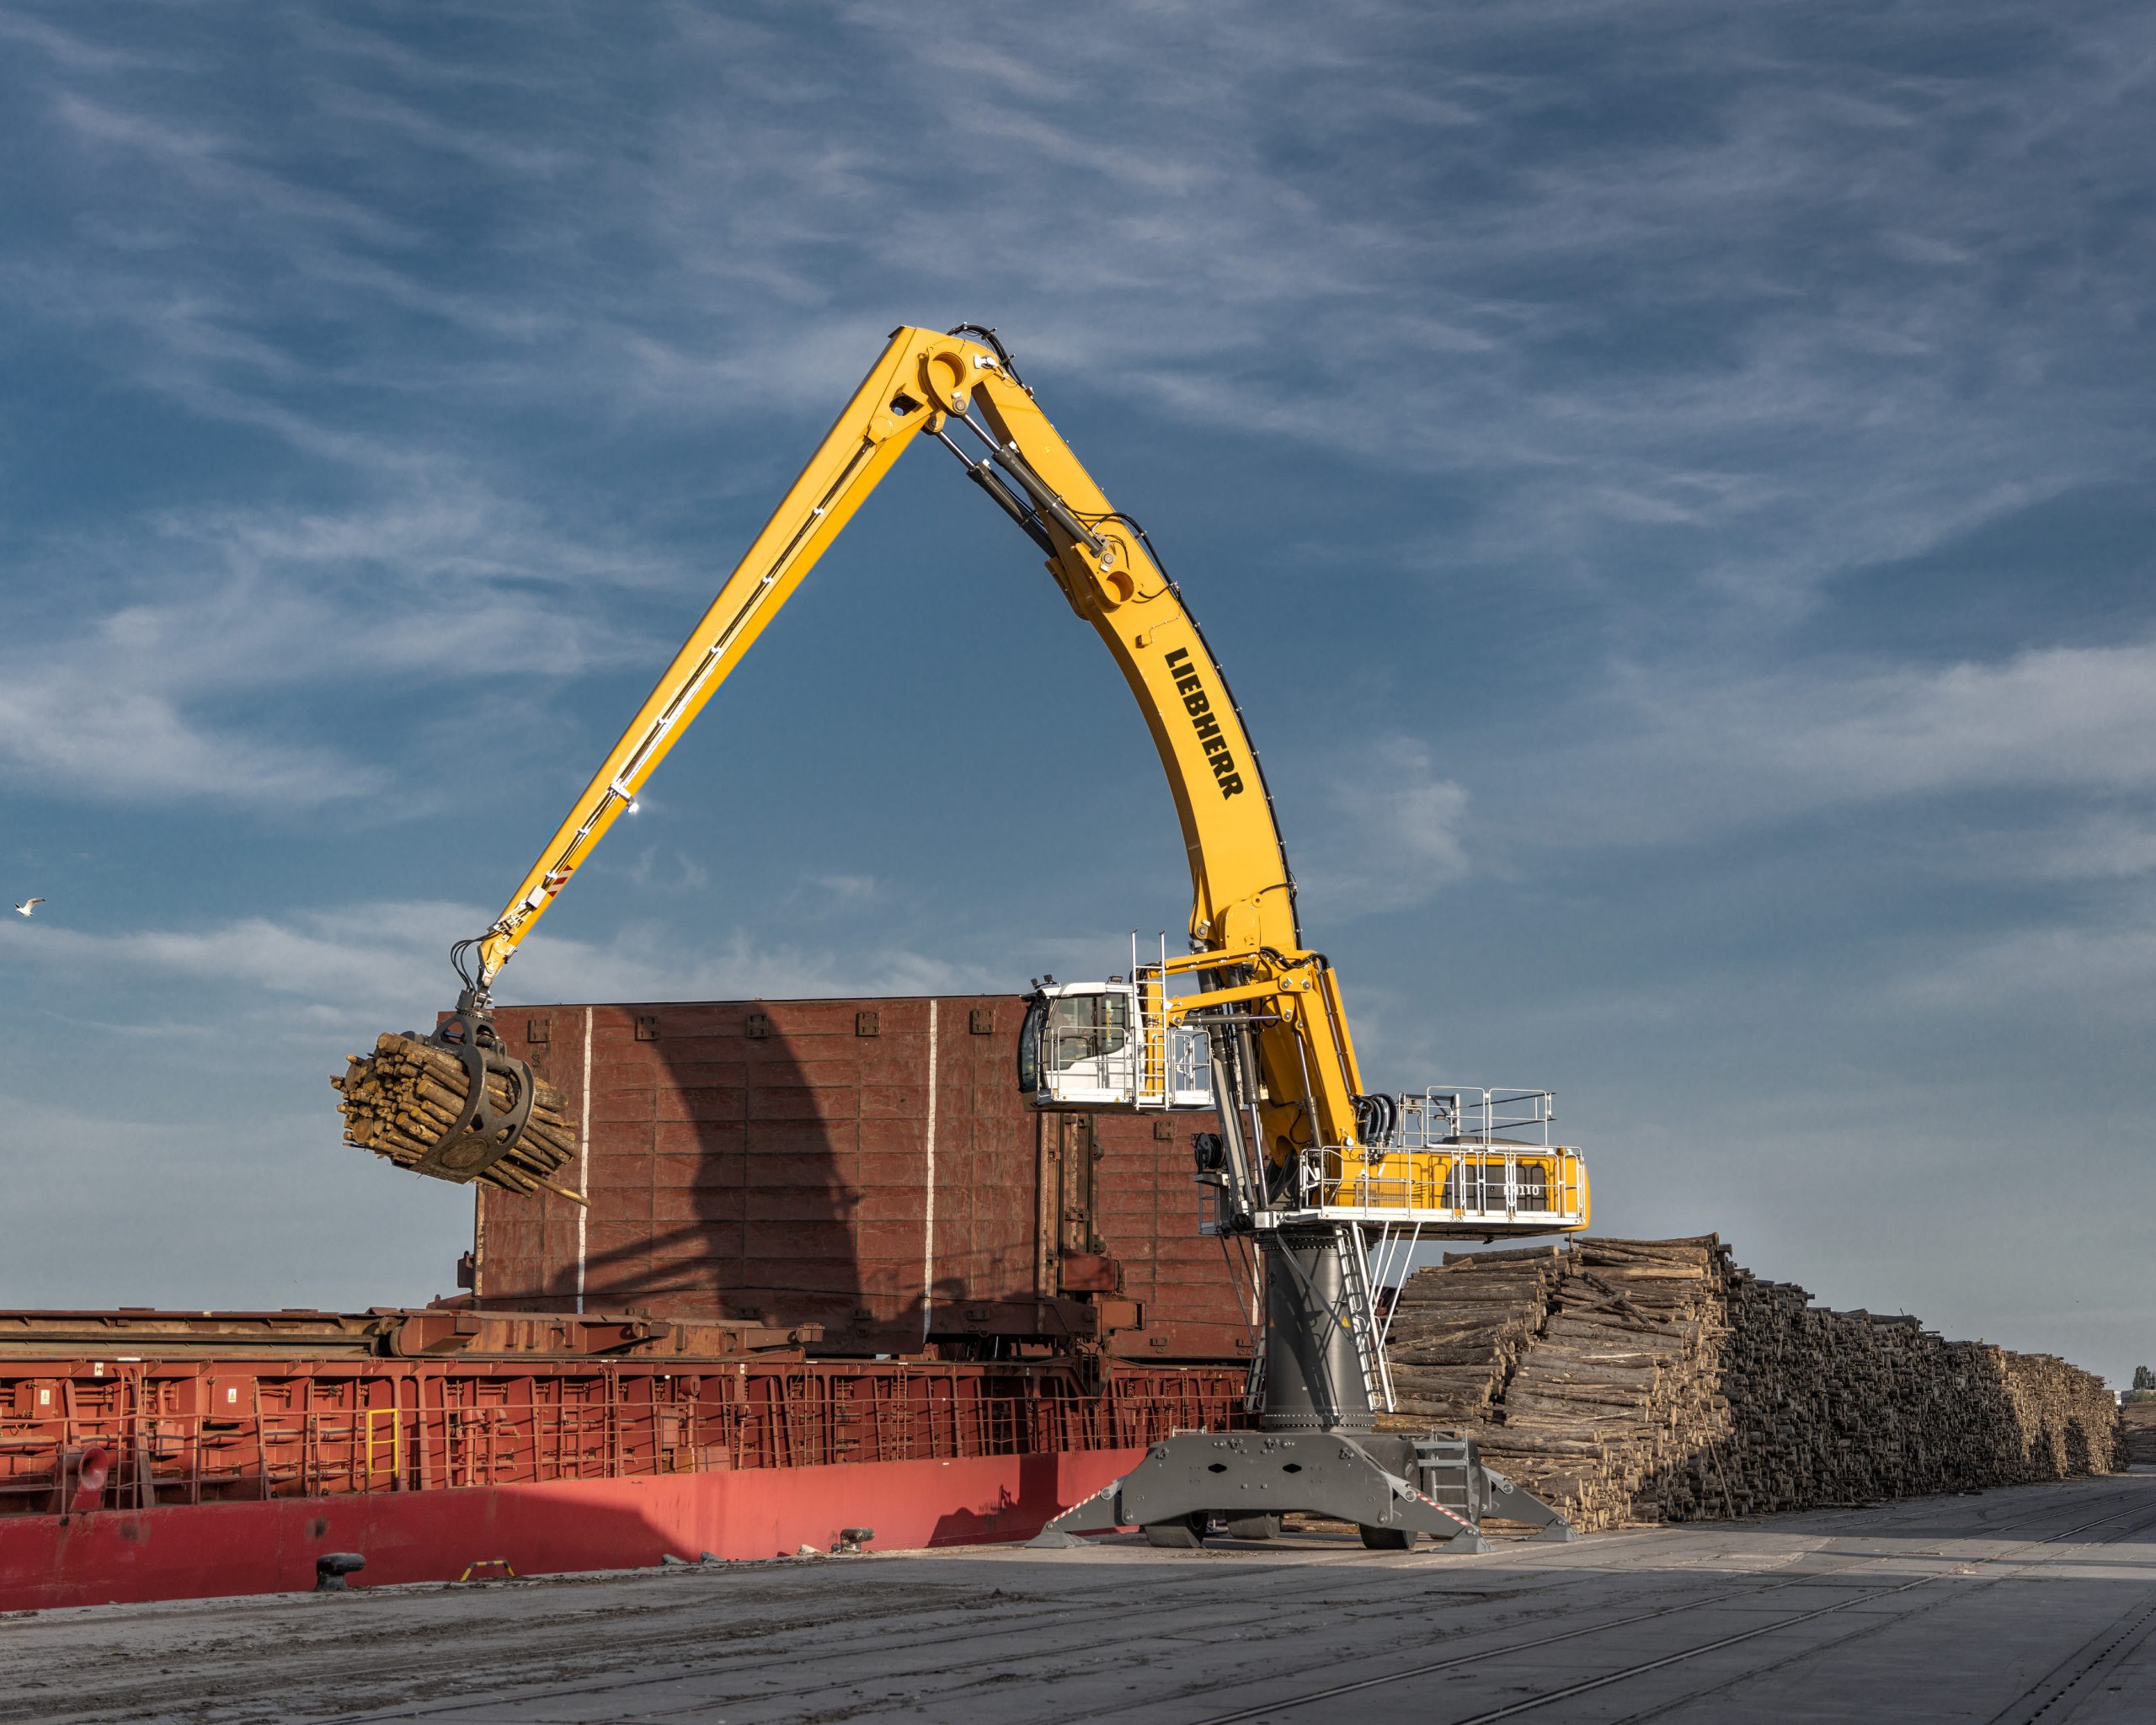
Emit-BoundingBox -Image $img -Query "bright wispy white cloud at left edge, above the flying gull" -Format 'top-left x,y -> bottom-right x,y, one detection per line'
0,485 -> 673,809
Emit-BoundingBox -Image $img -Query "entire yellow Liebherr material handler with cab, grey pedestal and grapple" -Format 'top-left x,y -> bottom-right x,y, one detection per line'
375,323 -> 1589,1548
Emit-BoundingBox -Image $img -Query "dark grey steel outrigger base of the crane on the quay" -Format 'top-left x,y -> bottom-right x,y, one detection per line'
1033,1432 -> 1490,1552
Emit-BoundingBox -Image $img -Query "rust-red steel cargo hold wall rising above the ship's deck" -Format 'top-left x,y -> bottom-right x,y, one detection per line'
470,994 -> 1255,1360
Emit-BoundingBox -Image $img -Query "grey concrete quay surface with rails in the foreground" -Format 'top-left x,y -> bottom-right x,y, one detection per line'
0,1468 -> 2156,1725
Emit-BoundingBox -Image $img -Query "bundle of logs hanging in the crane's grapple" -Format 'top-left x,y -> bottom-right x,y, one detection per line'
330,1033 -> 584,1203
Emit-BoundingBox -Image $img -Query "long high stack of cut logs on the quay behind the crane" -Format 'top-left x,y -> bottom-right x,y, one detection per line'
1380,1236 -> 2124,1529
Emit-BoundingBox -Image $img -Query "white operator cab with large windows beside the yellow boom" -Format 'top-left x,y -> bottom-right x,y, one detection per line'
1017,977 -> 1212,1108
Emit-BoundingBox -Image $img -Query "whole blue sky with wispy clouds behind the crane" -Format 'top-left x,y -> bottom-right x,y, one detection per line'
0,0 -> 2156,1380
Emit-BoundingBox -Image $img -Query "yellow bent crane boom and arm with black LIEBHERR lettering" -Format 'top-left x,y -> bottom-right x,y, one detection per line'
468,328 -> 1360,1162
